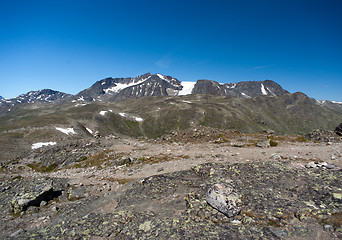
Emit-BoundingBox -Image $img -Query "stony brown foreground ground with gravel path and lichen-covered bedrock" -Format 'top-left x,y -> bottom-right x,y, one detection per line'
0,132 -> 342,239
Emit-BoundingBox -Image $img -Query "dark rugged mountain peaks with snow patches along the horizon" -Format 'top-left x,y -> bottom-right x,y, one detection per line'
0,73 -> 316,110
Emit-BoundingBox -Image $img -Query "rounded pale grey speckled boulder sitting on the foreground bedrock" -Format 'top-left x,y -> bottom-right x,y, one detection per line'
207,183 -> 241,217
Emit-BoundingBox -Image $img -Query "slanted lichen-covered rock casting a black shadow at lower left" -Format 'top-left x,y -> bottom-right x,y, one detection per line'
11,178 -> 53,214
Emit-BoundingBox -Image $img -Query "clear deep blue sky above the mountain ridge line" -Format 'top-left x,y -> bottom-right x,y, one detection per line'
0,0 -> 342,101
